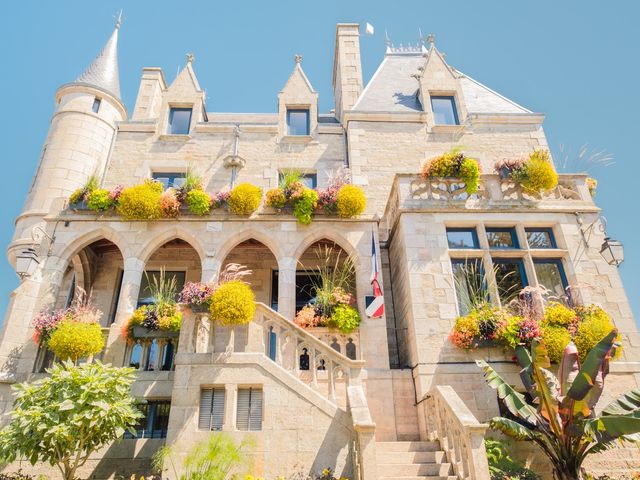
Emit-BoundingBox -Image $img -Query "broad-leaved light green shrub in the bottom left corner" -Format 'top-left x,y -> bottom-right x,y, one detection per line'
0,362 -> 142,480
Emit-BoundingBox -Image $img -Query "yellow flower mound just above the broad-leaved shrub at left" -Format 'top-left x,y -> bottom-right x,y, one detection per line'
47,320 -> 105,363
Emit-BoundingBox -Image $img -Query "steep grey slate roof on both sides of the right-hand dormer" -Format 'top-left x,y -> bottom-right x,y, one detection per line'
353,52 -> 532,114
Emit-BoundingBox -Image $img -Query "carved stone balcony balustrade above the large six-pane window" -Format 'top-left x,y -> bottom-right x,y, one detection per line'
384,174 -> 597,232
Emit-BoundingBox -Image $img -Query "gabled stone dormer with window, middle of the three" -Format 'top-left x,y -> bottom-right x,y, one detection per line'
278,55 -> 318,139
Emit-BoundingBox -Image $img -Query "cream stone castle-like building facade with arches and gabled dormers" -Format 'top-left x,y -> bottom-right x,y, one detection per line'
0,19 -> 640,480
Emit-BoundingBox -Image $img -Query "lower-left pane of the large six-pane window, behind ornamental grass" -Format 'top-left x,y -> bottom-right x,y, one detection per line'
451,258 -> 488,315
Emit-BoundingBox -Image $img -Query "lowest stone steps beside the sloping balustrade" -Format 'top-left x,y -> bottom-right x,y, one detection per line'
376,441 -> 456,480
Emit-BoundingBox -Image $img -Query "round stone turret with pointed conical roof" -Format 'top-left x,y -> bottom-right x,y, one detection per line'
8,18 -> 127,265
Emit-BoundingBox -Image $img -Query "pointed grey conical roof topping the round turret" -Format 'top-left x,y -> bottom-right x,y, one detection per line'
74,12 -> 122,99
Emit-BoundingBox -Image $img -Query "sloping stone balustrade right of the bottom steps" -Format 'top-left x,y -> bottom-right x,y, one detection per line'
423,385 -> 489,480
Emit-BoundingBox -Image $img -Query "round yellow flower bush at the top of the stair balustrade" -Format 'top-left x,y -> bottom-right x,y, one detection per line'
209,280 -> 256,326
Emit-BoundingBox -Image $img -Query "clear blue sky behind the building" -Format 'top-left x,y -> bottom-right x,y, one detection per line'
0,0 -> 640,314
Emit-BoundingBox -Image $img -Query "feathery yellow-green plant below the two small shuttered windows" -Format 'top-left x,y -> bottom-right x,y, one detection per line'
153,432 -> 255,480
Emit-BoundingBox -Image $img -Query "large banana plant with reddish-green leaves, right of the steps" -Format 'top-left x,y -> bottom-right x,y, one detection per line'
476,330 -> 640,480
